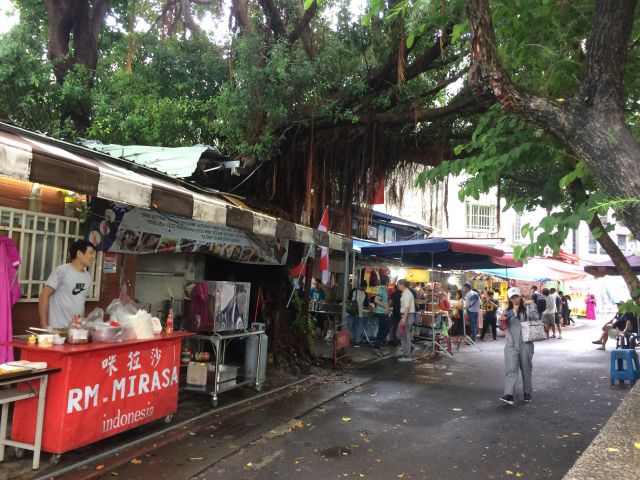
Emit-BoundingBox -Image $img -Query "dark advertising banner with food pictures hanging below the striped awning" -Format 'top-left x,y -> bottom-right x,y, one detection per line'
87,199 -> 288,265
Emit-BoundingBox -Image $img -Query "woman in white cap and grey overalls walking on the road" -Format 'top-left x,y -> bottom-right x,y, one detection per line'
500,287 -> 533,405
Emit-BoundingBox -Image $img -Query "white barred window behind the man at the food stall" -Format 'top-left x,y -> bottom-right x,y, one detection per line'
0,207 -> 102,302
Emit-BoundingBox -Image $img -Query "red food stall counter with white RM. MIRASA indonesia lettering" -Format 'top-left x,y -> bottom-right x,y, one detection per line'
12,332 -> 192,454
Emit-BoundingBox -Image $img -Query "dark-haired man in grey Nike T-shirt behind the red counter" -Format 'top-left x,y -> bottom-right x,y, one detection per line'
38,240 -> 96,328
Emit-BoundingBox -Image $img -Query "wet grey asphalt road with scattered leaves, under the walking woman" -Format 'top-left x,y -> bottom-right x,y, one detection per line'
102,322 -> 628,480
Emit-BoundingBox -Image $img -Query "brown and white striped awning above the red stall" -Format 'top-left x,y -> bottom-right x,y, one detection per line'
0,122 -> 352,250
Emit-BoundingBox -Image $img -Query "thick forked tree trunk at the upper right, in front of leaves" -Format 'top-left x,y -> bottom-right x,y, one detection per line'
466,0 -> 640,294
